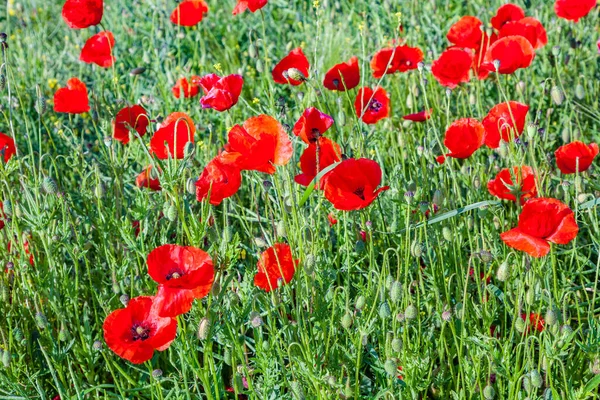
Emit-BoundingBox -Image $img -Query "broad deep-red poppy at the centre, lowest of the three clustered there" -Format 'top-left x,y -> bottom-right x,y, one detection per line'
324,158 -> 390,211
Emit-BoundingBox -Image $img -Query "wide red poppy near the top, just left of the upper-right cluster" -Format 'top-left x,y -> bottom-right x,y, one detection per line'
371,46 -> 423,79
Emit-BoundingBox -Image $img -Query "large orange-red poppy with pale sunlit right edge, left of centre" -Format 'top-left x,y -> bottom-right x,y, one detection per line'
223,115 -> 293,174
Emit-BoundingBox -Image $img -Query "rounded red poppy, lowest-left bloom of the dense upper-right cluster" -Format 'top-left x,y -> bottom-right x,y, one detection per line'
431,47 -> 473,89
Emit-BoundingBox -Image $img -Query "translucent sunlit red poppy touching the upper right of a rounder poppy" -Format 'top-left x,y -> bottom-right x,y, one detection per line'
483,101 -> 529,149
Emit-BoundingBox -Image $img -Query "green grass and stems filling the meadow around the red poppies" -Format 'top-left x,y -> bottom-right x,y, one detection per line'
0,0 -> 600,399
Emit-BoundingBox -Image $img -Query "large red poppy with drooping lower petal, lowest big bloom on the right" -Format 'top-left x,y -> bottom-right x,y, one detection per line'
500,197 -> 579,257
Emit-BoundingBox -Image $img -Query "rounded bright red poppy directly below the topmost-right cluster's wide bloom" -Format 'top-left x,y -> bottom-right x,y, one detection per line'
482,36 -> 535,74
